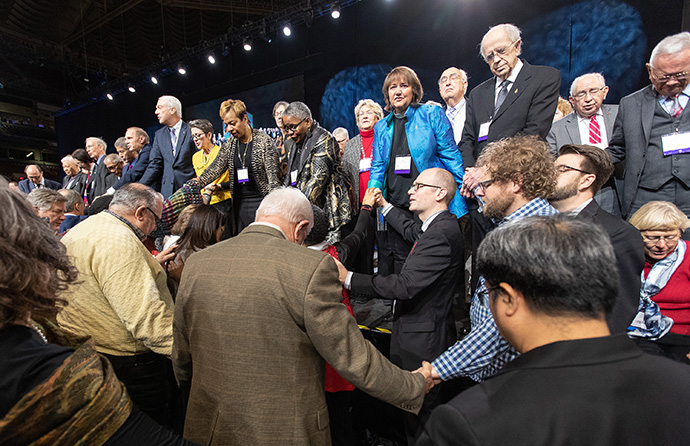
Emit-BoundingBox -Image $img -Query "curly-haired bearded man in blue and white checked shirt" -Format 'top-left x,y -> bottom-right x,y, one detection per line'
432,136 -> 558,383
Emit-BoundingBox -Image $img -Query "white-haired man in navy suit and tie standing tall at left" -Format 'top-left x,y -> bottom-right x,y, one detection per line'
139,96 -> 196,198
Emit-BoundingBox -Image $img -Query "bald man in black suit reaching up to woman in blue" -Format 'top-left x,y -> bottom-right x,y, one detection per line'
339,168 -> 464,438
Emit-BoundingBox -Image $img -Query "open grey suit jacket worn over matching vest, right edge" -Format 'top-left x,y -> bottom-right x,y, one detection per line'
608,85 -> 690,218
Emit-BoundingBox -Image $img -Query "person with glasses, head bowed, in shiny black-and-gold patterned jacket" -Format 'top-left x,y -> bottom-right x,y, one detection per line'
283,101 -> 352,243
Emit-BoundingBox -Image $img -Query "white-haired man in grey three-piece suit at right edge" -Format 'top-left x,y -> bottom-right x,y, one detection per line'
608,32 -> 690,218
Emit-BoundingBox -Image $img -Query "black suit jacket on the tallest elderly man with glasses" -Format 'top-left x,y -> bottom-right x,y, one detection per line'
460,61 -> 561,167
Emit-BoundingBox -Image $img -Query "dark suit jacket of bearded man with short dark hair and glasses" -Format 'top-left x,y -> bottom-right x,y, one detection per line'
578,200 -> 645,333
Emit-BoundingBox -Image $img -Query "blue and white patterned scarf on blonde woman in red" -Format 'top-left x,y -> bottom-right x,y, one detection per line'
628,240 -> 686,340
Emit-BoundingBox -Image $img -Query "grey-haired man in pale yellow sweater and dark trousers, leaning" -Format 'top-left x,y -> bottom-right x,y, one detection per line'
58,183 -> 176,426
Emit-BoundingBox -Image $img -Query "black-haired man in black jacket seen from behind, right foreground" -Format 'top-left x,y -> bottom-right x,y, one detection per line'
417,217 -> 690,446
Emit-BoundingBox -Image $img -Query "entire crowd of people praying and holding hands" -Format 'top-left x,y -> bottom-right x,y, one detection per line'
0,24 -> 690,445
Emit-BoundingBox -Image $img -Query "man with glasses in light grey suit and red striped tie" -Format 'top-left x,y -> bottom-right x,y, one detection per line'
546,73 -> 622,216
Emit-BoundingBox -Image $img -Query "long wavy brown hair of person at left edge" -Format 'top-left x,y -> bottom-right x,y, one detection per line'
0,184 -> 78,328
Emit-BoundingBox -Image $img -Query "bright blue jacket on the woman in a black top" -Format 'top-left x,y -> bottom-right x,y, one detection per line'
369,104 -> 467,218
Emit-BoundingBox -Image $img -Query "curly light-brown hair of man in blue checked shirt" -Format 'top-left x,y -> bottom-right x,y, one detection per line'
477,136 -> 556,200
